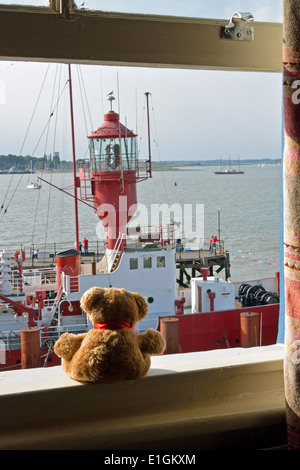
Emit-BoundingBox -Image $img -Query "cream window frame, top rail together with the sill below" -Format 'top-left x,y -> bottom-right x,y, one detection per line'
0,0 -> 285,449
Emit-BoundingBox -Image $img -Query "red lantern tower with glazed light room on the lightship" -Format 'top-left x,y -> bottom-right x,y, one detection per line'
79,93 -> 151,250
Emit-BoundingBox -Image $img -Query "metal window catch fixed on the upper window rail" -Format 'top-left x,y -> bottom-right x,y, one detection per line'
222,11 -> 254,41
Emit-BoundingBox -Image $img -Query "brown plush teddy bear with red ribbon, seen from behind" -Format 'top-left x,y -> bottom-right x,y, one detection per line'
54,287 -> 166,383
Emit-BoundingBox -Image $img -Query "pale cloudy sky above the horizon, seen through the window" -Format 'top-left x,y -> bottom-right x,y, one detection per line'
0,0 -> 282,161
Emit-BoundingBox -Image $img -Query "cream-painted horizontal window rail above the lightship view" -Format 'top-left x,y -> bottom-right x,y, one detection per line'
0,0 -> 282,73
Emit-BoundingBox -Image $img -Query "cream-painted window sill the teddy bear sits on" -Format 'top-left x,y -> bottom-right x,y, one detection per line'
0,345 -> 285,450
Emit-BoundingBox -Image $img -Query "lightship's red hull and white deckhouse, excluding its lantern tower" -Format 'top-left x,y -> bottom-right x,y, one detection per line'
0,242 -> 279,369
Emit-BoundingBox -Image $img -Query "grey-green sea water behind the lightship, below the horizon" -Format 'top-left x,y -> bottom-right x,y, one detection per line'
0,164 -> 281,281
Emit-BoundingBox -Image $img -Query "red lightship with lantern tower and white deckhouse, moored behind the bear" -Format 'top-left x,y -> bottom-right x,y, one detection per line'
0,72 -> 279,369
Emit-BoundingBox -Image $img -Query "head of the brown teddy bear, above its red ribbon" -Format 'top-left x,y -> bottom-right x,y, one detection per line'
80,287 -> 148,326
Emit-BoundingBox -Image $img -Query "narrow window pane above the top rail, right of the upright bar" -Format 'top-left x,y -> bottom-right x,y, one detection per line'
77,0 -> 282,22
